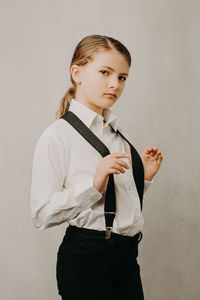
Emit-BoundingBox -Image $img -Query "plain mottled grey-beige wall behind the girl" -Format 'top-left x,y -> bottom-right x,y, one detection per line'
0,0 -> 200,300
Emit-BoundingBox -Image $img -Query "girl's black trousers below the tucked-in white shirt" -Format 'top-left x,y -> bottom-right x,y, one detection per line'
56,225 -> 144,300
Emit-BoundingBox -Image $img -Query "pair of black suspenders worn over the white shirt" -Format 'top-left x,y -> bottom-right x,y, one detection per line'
60,111 -> 144,239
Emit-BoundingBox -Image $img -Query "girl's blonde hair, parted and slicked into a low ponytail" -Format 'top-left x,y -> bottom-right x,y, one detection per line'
56,34 -> 131,120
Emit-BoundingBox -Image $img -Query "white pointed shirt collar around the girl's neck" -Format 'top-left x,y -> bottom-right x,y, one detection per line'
69,98 -> 118,131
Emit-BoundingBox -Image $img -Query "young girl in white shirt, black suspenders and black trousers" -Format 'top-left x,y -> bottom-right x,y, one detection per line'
31,35 -> 163,300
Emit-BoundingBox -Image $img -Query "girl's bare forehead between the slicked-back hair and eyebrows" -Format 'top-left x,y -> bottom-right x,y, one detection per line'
91,50 -> 129,73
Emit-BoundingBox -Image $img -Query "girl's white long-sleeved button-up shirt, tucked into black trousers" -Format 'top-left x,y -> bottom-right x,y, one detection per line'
30,99 -> 153,236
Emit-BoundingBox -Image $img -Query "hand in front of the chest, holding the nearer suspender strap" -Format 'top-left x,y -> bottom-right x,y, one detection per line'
93,153 -> 130,193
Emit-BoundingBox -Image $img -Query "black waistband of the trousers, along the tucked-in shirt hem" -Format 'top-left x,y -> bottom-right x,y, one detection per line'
66,224 -> 142,244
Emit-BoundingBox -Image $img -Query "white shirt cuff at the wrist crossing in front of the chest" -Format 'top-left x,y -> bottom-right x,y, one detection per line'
74,176 -> 103,207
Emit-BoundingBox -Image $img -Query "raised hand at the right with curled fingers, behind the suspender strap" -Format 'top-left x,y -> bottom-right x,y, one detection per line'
127,143 -> 163,181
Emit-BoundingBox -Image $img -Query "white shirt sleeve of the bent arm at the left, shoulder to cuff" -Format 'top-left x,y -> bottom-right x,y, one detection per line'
30,135 -> 103,230
